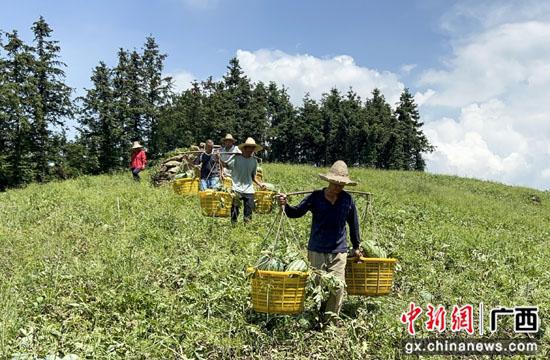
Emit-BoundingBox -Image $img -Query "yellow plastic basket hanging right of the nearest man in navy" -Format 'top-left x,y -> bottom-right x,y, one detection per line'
346,257 -> 397,296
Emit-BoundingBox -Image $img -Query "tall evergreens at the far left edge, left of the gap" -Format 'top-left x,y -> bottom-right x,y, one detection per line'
0,17 -> 74,188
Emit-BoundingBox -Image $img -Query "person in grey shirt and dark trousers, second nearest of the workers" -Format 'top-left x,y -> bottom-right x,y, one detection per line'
225,137 -> 265,223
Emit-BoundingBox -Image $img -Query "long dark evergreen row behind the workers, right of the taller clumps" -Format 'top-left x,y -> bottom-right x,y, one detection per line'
155,59 -> 432,170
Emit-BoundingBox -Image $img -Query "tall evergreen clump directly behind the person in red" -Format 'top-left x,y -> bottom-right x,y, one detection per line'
74,37 -> 173,174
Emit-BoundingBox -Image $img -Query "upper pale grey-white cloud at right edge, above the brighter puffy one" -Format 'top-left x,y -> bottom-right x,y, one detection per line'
420,22 -> 550,106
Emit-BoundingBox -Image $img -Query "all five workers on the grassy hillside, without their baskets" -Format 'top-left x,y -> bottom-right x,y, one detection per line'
131,134 -> 363,323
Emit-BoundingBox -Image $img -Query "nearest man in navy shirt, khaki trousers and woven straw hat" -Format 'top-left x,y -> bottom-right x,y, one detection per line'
279,160 -> 362,322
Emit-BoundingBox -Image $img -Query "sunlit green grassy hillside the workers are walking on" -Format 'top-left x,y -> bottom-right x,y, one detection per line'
0,165 -> 550,359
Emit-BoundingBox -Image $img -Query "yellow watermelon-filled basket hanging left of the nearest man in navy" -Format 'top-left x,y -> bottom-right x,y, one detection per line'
248,267 -> 309,314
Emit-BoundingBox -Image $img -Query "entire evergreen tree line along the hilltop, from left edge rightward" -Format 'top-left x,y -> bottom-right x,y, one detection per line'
0,17 -> 433,191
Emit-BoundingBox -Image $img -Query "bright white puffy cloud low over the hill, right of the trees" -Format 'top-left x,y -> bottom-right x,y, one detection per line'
425,100 -> 544,186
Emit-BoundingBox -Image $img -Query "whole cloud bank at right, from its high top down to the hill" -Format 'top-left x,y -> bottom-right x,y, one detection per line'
424,21 -> 550,189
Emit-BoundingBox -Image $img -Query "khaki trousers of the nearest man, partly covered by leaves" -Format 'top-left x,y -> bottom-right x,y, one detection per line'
307,250 -> 348,318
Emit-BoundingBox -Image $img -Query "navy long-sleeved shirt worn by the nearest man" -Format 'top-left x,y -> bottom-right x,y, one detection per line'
285,189 -> 361,253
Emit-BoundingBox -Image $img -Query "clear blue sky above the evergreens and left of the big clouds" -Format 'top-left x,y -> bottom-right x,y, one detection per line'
0,0 -> 448,93
